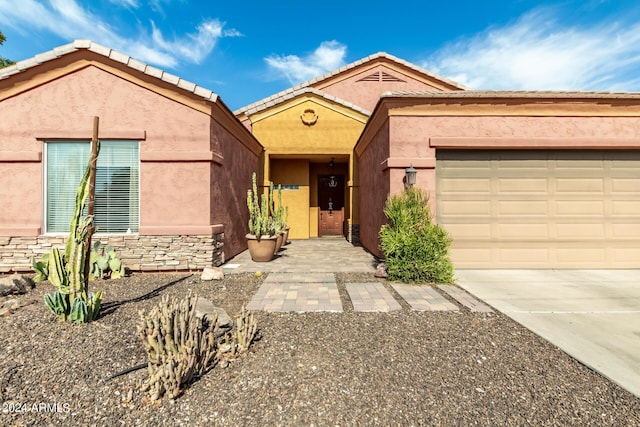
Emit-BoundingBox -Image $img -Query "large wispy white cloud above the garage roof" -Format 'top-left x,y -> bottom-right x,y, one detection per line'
422,9 -> 640,91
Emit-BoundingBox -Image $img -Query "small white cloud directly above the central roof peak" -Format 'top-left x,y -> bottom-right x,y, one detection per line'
265,40 -> 347,84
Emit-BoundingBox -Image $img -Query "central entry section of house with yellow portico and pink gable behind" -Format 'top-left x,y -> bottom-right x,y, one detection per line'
236,52 -> 464,242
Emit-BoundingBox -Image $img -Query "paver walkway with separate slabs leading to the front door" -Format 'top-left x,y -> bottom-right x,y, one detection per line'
232,239 -> 491,313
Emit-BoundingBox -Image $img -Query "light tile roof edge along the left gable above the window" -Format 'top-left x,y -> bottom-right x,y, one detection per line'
0,40 -> 218,102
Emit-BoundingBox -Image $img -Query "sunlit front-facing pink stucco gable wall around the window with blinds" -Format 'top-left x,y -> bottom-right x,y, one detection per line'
0,67 -> 210,234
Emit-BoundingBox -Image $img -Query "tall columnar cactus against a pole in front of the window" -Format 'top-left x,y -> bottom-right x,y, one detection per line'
38,142 -> 102,323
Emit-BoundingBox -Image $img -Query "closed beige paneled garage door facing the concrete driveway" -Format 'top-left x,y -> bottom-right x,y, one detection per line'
436,150 -> 640,268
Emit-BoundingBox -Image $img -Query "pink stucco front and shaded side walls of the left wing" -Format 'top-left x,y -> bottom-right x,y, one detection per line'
0,53 -> 261,268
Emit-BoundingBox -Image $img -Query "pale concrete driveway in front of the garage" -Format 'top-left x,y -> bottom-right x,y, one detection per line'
456,270 -> 640,397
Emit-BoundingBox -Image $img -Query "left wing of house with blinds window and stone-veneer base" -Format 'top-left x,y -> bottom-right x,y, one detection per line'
0,40 -> 263,271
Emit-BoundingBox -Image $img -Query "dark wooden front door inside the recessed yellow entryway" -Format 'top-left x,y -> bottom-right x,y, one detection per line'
318,175 -> 344,236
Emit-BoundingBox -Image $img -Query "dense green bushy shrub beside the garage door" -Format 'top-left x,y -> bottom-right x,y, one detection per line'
380,188 -> 453,283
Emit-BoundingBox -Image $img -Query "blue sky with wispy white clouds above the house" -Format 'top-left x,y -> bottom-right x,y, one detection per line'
0,0 -> 640,110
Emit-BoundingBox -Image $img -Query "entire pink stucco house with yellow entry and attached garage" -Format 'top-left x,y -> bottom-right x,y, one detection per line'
0,41 -> 640,271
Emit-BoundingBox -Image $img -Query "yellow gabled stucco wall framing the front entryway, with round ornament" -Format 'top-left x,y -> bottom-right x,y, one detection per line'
250,93 -> 368,239
